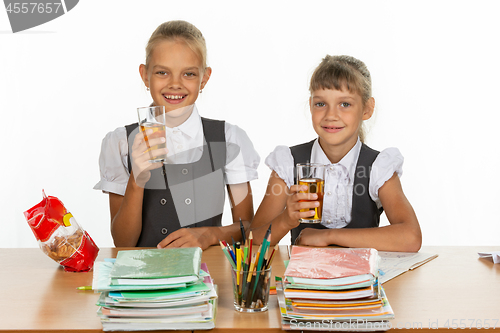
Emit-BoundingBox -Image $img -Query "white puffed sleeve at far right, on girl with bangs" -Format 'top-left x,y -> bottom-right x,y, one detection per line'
369,148 -> 404,207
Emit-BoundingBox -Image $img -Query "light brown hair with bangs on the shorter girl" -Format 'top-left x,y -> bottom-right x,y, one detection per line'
309,55 -> 372,142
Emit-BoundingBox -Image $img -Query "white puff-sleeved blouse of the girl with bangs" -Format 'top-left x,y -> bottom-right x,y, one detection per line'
265,139 -> 404,228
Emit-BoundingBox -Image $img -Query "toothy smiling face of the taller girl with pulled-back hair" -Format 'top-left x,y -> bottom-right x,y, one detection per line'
139,40 -> 211,112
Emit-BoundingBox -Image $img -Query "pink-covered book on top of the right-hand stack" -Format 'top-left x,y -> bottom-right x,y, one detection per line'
285,246 -> 378,279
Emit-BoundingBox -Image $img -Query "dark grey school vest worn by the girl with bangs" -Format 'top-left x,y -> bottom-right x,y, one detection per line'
290,140 -> 383,244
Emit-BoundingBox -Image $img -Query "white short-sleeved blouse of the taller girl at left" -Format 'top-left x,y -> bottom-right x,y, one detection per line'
94,106 -> 260,195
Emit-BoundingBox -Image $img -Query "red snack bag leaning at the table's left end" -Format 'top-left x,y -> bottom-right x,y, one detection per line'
24,191 -> 99,272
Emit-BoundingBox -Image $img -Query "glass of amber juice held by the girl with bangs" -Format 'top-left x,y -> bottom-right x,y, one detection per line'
296,163 -> 325,223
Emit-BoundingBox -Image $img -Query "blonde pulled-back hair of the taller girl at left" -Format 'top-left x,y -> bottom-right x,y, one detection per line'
145,21 -> 207,70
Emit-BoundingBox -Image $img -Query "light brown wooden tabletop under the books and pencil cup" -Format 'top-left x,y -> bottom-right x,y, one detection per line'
0,246 -> 500,333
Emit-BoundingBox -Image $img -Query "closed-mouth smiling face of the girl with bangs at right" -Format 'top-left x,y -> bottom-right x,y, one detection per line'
309,89 -> 375,163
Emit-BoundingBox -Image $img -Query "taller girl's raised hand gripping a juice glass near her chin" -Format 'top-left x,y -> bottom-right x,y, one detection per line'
130,129 -> 168,187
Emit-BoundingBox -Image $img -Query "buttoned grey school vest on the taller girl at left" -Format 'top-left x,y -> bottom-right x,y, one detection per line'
125,118 -> 226,247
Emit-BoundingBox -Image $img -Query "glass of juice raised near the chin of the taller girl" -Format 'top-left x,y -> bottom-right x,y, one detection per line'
137,106 -> 167,163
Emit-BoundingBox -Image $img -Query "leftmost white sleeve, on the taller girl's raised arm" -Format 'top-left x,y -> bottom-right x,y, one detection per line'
94,127 -> 130,195
